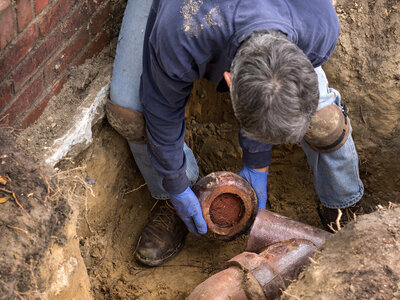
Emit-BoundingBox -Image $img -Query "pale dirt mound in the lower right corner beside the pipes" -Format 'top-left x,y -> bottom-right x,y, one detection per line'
282,207 -> 400,300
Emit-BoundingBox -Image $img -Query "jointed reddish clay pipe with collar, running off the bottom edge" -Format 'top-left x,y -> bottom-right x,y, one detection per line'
187,239 -> 317,300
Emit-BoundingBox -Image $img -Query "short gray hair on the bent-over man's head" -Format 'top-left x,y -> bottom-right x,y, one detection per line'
230,30 -> 319,144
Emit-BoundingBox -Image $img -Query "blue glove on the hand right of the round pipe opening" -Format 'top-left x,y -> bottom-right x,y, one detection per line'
238,166 -> 269,209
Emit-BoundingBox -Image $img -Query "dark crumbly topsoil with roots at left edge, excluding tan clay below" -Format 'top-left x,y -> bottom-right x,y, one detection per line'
0,130 -> 71,299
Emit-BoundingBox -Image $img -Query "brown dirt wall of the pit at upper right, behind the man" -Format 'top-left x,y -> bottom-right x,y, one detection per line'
325,0 -> 400,203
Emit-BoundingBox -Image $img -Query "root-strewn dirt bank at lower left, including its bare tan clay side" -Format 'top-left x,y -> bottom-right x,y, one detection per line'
0,130 -> 92,300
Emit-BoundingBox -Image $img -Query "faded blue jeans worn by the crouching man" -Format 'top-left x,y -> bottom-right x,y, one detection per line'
110,0 -> 363,208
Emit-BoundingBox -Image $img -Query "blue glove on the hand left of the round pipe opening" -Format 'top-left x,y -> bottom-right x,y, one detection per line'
169,187 -> 207,235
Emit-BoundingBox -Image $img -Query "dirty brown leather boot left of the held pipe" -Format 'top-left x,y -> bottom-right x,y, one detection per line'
135,200 -> 188,266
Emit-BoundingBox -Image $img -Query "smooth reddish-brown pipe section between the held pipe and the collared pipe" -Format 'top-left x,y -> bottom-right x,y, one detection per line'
246,209 -> 331,252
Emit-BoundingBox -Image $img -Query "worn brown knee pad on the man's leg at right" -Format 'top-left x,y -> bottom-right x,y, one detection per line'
304,104 -> 350,153
